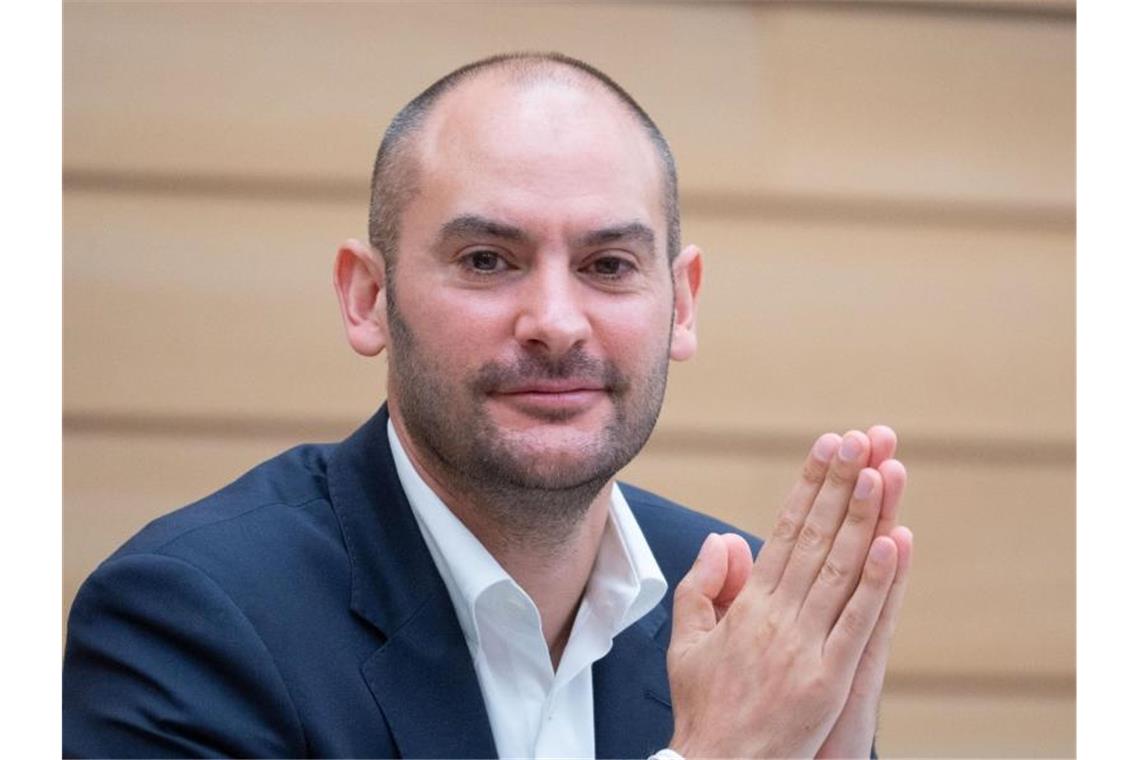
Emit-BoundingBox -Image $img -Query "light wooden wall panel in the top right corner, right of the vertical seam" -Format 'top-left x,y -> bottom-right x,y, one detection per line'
752,3 -> 1076,209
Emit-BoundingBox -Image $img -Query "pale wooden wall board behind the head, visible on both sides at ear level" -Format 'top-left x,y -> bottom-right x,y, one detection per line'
64,191 -> 1074,446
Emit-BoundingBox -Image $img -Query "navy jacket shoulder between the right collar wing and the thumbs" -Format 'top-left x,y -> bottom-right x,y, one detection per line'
620,483 -> 763,586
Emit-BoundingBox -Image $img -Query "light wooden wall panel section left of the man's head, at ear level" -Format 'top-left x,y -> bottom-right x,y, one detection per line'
64,193 -> 384,419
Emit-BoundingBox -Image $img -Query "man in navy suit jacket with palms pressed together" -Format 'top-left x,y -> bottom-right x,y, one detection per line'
64,55 -> 911,758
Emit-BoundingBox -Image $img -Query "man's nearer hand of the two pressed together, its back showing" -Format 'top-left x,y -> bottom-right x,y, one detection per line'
668,432 -> 899,758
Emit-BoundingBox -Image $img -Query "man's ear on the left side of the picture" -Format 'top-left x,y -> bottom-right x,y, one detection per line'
333,239 -> 388,357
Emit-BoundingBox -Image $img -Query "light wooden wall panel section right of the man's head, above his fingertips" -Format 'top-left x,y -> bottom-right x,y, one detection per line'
668,215 -> 1075,440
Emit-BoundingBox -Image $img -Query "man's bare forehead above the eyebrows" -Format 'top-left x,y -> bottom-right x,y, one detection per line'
409,73 -> 663,234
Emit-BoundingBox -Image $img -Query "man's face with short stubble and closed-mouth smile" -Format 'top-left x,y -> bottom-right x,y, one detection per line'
388,77 -> 688,490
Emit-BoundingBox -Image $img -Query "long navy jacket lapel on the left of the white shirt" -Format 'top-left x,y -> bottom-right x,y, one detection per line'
328,406 -> 496,758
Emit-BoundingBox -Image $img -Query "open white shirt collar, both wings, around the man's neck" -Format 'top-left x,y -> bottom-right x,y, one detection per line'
388,419 -> 668,648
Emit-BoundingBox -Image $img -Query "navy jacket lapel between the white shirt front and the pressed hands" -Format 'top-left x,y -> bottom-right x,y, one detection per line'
594,605 -> 673,758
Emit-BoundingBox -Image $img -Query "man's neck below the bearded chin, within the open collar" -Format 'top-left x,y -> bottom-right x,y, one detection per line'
393,416 -> 613,668
